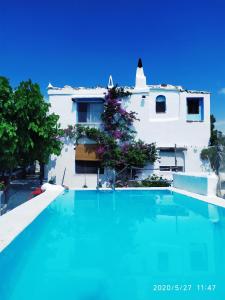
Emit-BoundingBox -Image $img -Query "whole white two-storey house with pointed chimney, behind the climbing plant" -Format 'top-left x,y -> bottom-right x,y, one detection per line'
47,60 -> 210,187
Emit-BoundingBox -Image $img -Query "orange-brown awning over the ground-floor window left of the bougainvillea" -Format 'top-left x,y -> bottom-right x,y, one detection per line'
75,144 -> 101,161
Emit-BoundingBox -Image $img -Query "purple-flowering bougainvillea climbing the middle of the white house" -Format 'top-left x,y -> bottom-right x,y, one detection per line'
65,87 -> 157,170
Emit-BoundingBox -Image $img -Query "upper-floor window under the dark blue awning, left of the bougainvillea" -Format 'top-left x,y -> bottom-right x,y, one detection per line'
77,102 -> 103,123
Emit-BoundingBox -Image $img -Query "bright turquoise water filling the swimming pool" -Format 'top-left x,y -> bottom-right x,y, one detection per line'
0,190 -> 225,300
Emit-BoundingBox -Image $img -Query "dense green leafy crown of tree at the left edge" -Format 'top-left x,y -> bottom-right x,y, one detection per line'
0,77 -> 63,177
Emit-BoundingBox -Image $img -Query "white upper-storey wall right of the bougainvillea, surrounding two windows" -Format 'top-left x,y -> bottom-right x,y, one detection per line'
124,90 -> 210,147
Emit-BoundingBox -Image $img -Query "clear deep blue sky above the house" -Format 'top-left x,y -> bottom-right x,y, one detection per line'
0,0 -> 225,132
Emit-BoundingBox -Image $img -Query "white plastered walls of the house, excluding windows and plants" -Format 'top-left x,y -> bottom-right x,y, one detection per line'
48,86 -> 210,187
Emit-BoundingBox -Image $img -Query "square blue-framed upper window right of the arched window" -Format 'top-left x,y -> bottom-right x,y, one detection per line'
187,97 -> 204,122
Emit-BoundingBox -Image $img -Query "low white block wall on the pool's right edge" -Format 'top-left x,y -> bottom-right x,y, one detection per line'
173,172 -> 218,196
